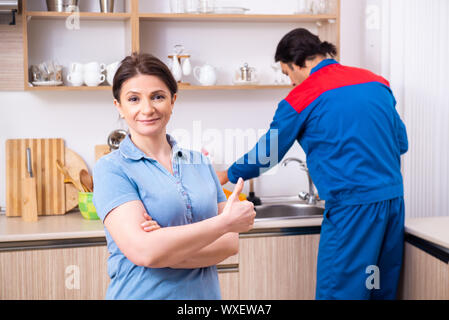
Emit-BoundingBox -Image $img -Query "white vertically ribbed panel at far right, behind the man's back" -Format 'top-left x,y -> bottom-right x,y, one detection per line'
383,0 -> 449,217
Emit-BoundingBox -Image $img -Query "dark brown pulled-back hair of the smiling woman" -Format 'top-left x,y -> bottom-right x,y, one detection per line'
112,52 -> 178,102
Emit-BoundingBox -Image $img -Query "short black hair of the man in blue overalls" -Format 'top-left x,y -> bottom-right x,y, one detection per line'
274,28 -> 337,68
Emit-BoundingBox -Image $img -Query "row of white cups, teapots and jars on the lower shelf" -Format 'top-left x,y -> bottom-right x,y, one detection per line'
28,44 -> 291,90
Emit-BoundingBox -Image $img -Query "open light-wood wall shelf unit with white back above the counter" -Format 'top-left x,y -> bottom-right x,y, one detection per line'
18,0 -> 340,91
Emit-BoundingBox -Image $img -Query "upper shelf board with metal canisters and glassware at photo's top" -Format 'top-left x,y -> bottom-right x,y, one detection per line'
26,0 -> 338,21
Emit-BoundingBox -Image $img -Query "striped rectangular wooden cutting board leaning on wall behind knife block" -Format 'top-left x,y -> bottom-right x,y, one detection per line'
6,139 -> 66,217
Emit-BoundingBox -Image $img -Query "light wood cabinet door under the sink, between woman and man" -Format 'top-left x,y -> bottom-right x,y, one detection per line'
239,235 -> 320,300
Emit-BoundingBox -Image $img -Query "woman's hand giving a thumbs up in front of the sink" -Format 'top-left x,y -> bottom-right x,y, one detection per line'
221,178 -> 256,233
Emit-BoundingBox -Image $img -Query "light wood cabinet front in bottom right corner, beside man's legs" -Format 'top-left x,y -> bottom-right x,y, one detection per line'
398,242 -> 449,300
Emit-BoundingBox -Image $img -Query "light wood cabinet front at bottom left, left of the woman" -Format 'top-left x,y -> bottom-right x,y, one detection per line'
0,246 -> 109,300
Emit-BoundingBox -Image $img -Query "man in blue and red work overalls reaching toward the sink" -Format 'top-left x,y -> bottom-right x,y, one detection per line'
218,29 -> 408,299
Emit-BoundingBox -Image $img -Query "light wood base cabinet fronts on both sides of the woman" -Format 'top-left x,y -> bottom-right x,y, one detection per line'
0,234 -> 319,300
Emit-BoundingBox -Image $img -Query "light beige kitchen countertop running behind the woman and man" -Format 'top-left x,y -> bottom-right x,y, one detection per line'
0,211 -> 449,249
